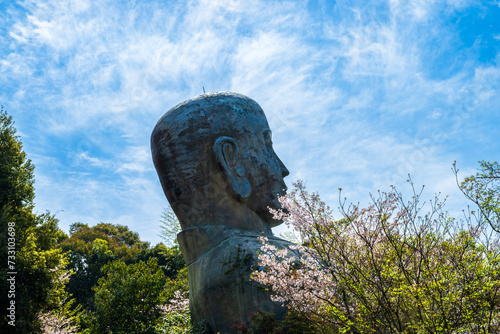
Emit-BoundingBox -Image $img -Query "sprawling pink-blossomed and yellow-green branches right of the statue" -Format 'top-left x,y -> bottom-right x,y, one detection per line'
254,182 -> 500,333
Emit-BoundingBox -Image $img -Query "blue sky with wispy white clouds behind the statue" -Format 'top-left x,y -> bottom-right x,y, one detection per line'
0,0 -> 500,244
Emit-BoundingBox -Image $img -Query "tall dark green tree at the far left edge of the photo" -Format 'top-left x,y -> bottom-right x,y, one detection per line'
0,108 -> 71,333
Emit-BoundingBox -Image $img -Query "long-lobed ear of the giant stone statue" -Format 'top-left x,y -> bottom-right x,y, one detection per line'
214,137 -> 252,201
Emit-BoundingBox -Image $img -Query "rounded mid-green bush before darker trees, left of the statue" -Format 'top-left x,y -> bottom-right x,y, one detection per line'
92,258 -> 165,333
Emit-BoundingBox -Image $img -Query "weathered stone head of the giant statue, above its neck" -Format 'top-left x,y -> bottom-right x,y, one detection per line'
151,92 -> 289,233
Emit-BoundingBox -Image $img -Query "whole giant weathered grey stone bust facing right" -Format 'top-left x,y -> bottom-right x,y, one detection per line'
151,92 -> 291,333
